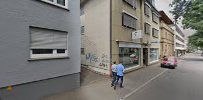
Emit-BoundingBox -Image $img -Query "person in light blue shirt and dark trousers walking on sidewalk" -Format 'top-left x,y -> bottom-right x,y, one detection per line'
114,63 -> 124,89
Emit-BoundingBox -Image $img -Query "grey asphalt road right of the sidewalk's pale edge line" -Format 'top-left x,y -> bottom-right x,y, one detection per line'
124,55 -> 203,100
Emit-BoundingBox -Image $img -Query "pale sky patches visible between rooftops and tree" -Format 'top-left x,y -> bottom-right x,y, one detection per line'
155,0 -> 194,37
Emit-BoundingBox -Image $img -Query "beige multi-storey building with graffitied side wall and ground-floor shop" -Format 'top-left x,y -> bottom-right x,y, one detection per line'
81,0 -> 160,74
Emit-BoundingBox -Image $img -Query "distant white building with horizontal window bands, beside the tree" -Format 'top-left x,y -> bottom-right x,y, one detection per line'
172,24 -> 186,56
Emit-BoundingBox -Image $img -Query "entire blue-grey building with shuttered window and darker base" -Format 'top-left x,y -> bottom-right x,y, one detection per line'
0,0 -> 81,100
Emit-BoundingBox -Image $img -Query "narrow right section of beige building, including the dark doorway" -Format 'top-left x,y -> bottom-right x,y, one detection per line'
142,0 -> 160,65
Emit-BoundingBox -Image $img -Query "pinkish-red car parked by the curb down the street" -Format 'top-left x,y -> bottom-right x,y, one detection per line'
161,57 -> 177,69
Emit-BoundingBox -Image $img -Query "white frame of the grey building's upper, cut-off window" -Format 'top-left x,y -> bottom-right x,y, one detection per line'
40,0 -> 68,9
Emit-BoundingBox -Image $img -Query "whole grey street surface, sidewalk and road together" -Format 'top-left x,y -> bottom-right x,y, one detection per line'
43,54 -> 203,100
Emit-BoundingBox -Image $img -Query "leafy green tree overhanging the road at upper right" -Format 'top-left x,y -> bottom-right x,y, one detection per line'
170,0 -> 203,48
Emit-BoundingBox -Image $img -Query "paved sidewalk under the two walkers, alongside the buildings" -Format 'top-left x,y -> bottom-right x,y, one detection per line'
42,64 -> 165,100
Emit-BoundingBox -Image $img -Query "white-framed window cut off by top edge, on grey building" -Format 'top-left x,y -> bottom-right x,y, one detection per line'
41,0 -> 68,9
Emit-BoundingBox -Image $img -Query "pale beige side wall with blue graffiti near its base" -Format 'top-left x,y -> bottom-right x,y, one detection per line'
81,0 -> 110,74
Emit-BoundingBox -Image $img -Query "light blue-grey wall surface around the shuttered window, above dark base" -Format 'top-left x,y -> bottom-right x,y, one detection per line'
0,0 -> 80,100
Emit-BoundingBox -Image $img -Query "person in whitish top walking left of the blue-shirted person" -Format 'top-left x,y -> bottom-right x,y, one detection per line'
111,61 -> 117,87
